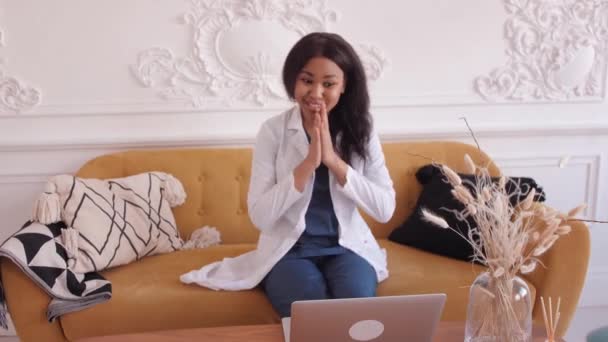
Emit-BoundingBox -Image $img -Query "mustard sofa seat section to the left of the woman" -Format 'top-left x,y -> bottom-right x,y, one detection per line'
61,244 -> 279,340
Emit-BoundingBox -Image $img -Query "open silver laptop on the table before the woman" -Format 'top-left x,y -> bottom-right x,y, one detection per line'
281,293 -> 446,342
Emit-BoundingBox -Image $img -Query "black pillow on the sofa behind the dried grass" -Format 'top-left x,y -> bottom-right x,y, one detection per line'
388,165 -> 545,261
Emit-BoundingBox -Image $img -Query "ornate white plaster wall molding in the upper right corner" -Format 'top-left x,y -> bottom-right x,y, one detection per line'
474,0 -> 608,102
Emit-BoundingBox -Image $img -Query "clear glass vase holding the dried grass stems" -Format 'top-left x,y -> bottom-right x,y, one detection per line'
465,272 -> 532,342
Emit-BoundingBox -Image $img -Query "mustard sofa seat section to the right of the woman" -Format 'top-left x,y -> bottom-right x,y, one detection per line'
377,239 -> 536,321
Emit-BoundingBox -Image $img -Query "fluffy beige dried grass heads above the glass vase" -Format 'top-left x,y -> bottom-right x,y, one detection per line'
422,154 -> 585,279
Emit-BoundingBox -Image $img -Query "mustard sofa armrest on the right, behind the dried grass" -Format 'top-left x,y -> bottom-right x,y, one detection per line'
525,215 -> 590,336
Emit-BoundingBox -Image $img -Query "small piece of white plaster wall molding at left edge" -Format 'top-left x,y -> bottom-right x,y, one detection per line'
0,30 -> 40,115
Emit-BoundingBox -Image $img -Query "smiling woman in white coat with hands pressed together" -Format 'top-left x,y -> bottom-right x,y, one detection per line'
182,33 -> 395,317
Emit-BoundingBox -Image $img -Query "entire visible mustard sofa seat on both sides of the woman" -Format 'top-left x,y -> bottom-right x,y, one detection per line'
61,239 -> 535,340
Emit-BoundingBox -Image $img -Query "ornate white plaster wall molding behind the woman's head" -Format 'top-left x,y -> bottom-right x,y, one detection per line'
132,0 -> 388,107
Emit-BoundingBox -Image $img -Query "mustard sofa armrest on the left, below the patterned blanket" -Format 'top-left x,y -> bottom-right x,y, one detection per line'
0,258 -> 66,342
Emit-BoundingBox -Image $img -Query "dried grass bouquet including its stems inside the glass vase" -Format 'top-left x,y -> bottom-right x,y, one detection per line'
422,155 -> 585,341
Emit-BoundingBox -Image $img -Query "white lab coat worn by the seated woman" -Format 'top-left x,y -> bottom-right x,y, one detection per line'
180,106 -> 395,291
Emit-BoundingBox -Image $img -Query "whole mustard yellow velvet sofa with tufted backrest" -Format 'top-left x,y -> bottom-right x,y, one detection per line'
1,142 -> 590,342
